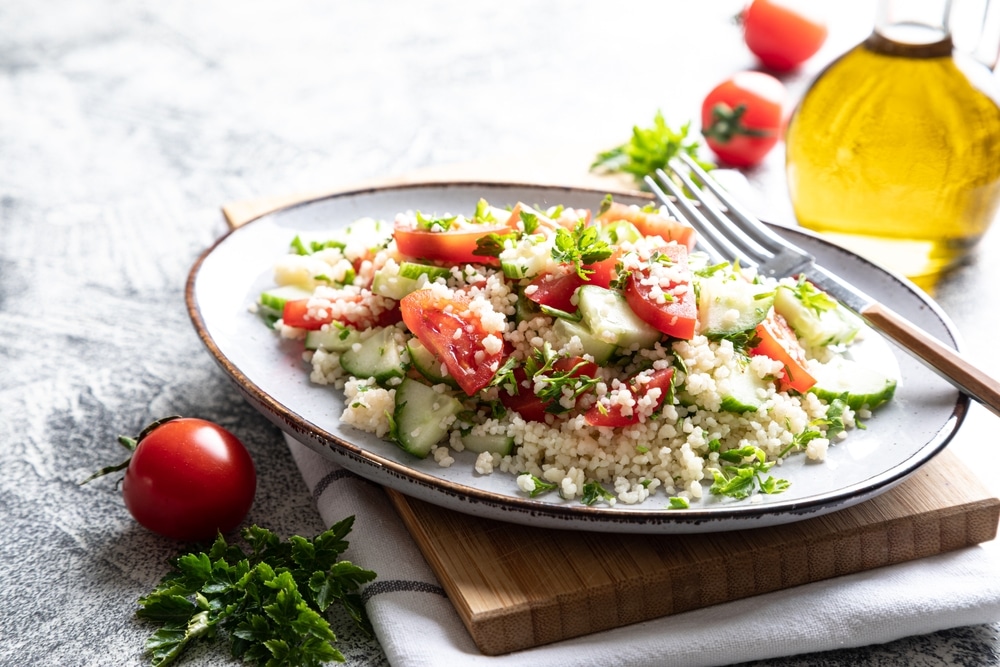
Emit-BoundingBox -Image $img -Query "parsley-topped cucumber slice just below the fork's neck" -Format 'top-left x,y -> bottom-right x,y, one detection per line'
774,283 -> 861,347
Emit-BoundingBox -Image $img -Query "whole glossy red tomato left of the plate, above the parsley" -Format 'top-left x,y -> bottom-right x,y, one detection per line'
115,417 -> 257,541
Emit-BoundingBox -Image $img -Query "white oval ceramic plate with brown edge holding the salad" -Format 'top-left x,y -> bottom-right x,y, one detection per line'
187,183 -> 968,533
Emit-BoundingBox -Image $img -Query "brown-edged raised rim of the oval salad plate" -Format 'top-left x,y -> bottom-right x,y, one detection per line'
185,181 -> 969,533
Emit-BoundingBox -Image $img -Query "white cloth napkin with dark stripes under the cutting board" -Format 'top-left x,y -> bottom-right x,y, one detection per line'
286,437 -> 1000,667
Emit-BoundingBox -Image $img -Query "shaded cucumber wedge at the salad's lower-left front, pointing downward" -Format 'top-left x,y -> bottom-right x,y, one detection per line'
392,378 -> 462,458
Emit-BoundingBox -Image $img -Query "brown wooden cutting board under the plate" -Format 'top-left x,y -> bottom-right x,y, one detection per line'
223,166 -> 1000,655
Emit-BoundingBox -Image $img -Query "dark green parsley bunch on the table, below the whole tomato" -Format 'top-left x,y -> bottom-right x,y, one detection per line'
136,517 -> 376,667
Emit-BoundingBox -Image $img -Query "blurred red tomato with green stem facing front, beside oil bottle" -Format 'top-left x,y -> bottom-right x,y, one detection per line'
701,71 -> 788,167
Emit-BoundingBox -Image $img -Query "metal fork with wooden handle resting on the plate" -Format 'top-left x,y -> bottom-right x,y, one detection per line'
645,154 -> 1000,416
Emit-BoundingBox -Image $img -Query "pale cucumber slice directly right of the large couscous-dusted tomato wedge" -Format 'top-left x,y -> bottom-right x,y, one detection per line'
698,273 -> 774,338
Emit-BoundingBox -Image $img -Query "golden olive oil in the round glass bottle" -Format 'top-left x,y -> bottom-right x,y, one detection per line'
786,32 -> 1000,289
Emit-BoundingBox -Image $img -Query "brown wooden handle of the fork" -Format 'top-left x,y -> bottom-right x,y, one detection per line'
859,303 -> 1000,416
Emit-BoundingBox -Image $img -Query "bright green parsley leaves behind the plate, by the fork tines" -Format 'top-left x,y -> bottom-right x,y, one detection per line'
590,111 -> 713,188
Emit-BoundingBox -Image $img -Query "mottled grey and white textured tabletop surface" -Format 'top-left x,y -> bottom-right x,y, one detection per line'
0,0 -> 1000,667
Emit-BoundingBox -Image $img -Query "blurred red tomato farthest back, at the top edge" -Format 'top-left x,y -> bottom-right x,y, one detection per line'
743,0 -> 827,72
